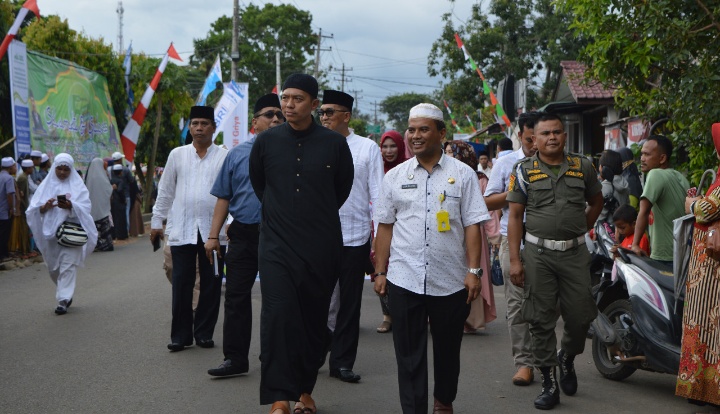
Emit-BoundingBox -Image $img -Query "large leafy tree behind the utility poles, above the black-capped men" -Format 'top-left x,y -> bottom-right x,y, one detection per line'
190,3 -> 316,103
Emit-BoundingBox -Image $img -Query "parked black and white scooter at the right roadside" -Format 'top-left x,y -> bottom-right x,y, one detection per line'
592,249 -> 685,381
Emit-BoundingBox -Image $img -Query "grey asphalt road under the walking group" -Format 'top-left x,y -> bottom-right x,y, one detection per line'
0,238 -> 711,414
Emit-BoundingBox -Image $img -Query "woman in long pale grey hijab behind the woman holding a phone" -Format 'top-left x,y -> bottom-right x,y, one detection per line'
85,158 -> 113,252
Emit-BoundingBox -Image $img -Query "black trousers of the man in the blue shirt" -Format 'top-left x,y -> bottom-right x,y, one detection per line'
223,220 -> 260,370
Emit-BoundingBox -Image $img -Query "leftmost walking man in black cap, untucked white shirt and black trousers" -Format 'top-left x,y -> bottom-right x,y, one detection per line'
150,106 -> 227,352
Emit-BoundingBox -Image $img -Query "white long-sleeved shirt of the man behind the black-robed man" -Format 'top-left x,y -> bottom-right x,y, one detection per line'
340,133 -> 384,246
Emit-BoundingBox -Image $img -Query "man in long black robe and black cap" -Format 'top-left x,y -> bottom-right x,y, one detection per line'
250,74 -> 354,414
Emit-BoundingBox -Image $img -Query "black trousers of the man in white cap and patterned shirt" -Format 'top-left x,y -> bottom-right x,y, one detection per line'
388,282 -> 470,414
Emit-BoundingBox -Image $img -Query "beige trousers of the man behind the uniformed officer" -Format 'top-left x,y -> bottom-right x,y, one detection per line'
500,236 -> 533,368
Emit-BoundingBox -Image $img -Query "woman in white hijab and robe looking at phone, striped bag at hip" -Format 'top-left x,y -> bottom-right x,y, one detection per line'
27,153 -> 97,315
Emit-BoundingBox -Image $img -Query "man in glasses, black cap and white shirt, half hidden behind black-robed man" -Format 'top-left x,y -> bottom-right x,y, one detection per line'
318,90 -> 383,382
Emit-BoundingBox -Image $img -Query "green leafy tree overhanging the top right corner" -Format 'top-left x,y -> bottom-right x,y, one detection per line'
558,0 -> 720,179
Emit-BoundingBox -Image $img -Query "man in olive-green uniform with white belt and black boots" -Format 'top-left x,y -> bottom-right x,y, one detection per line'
507,113 -> 603,410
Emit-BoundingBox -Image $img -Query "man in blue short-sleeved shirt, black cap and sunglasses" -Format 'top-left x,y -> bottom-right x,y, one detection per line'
205,93 -> 285,377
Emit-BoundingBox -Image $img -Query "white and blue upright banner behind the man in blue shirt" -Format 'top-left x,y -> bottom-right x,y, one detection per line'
213,82 -> 250,149
